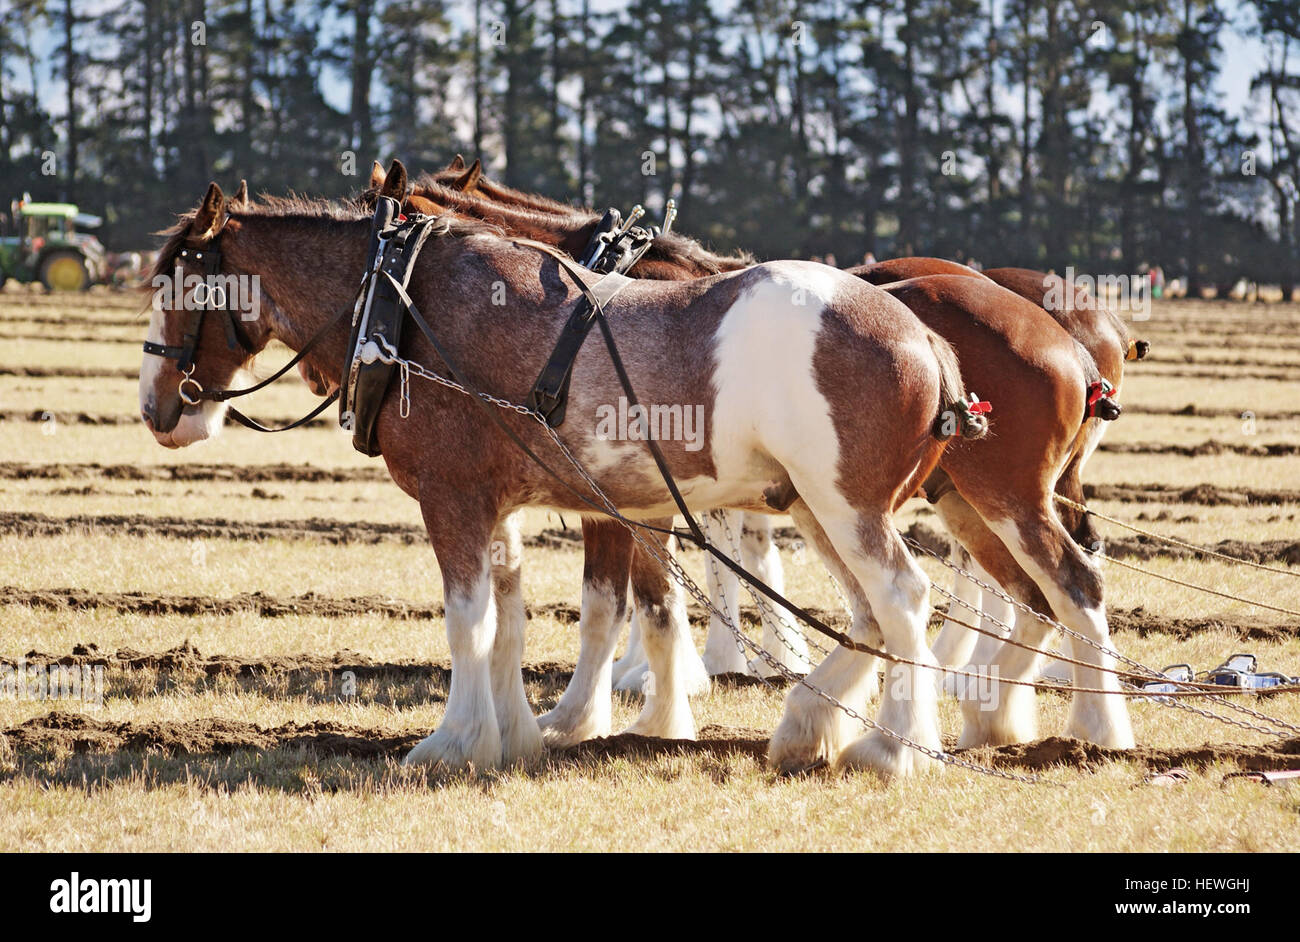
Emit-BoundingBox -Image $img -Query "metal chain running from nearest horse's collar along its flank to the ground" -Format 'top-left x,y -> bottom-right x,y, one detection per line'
377,338 -> 1040,787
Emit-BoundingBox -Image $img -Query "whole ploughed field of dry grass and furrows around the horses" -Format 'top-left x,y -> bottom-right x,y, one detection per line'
0,290 -> 1300,851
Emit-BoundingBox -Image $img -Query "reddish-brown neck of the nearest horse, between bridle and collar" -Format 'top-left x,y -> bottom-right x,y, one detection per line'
225,216 -> 371,382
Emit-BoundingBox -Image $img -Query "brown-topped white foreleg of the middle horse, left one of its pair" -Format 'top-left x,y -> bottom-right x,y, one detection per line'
538,517 -> 633,746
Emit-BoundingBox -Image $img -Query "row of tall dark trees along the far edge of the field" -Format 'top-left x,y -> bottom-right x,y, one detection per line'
0,0 -> 1300,291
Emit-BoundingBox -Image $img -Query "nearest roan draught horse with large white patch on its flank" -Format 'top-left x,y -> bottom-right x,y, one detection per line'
140,185 -> 965,774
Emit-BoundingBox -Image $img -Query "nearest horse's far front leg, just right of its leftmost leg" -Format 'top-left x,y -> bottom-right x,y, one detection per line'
489,515 -> 542,763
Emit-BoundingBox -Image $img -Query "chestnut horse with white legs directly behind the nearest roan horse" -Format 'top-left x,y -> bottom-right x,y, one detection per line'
379,163 -> 1132,768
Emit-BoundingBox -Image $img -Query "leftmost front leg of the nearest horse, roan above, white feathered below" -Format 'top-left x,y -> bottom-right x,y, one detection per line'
406,487 -> 502,769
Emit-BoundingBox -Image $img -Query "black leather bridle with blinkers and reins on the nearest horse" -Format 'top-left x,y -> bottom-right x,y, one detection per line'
144,214 -> 351,431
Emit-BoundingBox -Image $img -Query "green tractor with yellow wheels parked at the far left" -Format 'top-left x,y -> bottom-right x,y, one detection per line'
0,195 -> 108,291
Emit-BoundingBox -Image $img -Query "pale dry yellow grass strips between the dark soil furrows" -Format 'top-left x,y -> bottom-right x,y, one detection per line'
0,292 -> 1300,852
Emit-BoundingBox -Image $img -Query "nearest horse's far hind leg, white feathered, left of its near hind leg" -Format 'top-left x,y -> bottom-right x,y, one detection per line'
767,500 -> 883,772
